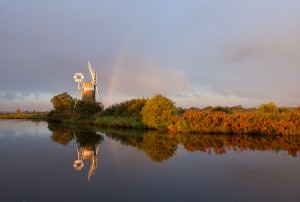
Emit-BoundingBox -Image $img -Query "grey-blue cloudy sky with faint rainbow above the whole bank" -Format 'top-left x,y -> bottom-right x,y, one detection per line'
0,0 -> 300,111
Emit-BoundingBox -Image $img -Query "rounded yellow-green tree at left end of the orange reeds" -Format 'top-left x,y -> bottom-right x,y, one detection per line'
141,94 -> 176,129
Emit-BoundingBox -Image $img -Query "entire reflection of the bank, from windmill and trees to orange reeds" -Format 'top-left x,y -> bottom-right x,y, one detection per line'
49,125 -> 300,172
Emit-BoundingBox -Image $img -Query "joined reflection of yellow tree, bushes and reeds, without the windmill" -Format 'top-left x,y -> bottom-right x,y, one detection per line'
101,129 -> 300,158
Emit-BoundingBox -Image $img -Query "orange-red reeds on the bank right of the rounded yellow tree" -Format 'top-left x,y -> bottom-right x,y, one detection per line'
168,110 -> 300,135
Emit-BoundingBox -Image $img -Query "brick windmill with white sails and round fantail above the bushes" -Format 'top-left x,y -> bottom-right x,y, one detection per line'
74,62 -> 102,102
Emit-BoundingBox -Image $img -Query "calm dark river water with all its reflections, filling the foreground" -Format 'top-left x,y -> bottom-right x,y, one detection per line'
0,120 -> 300,201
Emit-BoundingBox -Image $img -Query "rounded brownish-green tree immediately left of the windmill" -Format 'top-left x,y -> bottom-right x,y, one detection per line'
51,92 -> 73,113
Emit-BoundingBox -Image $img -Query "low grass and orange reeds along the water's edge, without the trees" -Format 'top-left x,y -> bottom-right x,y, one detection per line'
0,110 -> 300,135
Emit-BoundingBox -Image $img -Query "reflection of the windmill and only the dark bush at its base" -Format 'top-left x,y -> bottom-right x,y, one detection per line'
73,130 -> 104,181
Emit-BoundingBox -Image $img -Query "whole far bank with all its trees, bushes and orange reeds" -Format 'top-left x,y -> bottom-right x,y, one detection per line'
0,93 -> 300,135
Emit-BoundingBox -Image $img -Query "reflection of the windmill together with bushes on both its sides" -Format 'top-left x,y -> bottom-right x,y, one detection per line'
48,124 -> 104,181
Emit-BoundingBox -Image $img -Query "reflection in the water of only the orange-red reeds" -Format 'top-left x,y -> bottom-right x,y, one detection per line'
178,134 -> 300,157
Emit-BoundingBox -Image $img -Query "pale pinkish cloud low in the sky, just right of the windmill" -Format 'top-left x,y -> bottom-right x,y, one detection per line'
114,61 -> 193,96
